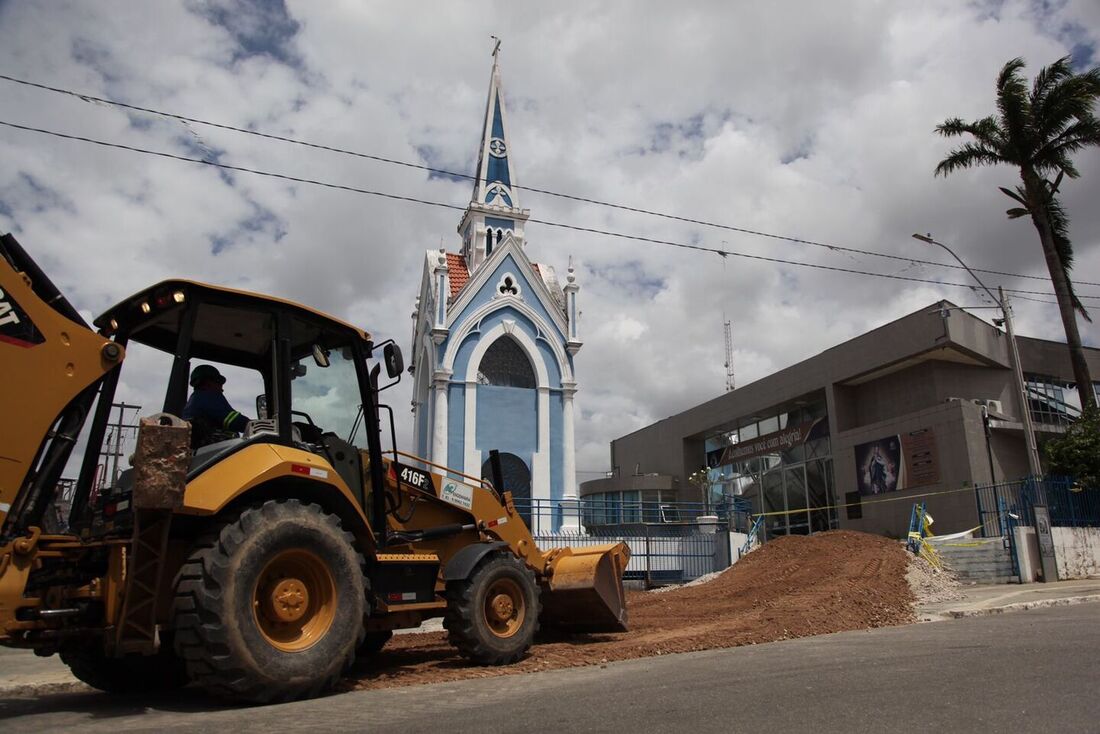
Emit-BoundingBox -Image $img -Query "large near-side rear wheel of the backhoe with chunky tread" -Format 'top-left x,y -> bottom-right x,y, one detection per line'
173,500 -> 366,703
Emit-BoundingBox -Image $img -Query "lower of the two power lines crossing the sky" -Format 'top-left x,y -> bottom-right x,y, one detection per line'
0,120 -> 1100,300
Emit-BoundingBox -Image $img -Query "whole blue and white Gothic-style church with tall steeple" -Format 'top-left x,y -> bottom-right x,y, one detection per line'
410,53 -> 581,532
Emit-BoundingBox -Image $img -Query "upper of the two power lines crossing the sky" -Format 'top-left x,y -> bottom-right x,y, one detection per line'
0,74 -> 1100,286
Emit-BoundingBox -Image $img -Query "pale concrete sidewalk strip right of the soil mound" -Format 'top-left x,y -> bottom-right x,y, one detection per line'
917,579 -> 1100,622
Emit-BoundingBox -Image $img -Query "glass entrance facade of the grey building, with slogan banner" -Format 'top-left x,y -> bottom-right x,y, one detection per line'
705,396 -> 838,537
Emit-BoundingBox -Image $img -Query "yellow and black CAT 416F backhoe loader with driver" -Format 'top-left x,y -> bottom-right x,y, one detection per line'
0,234 -> 629,702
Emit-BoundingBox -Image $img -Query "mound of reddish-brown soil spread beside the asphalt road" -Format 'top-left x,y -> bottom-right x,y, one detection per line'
344,530 -> 914,689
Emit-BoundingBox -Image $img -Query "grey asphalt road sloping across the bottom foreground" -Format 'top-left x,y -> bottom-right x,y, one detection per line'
0,604 -> 1100,734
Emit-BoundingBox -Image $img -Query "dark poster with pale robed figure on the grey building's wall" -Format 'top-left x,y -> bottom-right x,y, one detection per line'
856,428 -> 939,495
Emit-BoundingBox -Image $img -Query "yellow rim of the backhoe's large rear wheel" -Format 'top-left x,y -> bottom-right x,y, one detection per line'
252,549 -> 337,653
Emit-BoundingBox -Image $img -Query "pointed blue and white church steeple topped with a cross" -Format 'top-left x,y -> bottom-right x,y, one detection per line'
459,37 -> 529,273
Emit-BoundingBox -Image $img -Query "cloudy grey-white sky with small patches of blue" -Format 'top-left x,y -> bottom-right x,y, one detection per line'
0,0 -> 1100,480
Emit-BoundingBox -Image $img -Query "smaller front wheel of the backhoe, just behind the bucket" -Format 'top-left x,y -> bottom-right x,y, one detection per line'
443,552 -> 541,665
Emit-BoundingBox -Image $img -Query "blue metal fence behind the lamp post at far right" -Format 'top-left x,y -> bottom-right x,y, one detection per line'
976,476 -> 1100,538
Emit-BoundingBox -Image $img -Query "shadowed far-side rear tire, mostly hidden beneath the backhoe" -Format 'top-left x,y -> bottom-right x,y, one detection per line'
61,644 -> 187,693
